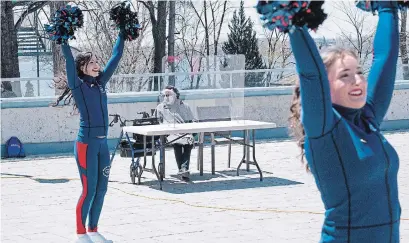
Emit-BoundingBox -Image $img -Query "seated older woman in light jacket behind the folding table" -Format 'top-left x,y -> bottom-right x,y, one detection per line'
155,85 -> 195,180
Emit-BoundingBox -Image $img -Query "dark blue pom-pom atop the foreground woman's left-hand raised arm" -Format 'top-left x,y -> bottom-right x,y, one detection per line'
256,1 -> 327,33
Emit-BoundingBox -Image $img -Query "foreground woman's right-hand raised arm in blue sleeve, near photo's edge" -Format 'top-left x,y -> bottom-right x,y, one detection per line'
367,1 -> 399,125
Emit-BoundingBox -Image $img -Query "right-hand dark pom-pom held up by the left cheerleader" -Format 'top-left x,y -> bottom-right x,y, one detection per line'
110,2 -> 141,41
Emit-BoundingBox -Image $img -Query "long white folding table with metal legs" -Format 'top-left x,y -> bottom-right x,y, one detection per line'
122,120 -> 276,189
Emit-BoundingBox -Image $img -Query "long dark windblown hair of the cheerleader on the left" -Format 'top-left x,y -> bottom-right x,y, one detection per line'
52,52 -> 93,112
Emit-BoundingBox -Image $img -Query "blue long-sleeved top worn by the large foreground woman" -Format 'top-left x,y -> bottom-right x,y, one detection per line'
290,3 -> 401,243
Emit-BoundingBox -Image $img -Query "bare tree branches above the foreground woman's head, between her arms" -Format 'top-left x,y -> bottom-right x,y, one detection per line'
334,1 -> 375,70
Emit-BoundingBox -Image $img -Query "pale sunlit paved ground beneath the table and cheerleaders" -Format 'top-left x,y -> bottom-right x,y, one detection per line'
1,132 -> 409,243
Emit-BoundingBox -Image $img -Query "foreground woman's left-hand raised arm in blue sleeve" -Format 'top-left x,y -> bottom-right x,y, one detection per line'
290,28 -> 334,137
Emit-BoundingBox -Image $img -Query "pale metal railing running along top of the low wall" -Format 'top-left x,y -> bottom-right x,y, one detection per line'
1,65 -> 409,97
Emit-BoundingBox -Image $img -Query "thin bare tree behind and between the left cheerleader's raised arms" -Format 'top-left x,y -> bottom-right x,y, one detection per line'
72,0 -> 153,92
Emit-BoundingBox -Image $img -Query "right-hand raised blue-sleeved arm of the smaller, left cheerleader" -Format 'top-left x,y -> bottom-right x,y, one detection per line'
99,32 -> 125,86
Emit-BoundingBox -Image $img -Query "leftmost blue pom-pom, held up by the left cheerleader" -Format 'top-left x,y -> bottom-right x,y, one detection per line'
44,5 -> 84,44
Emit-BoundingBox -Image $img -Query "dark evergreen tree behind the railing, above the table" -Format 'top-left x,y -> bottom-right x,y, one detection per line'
222,1 -> 265,87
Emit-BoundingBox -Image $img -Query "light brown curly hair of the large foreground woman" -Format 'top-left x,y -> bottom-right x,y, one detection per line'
288,46 -> 358,172
